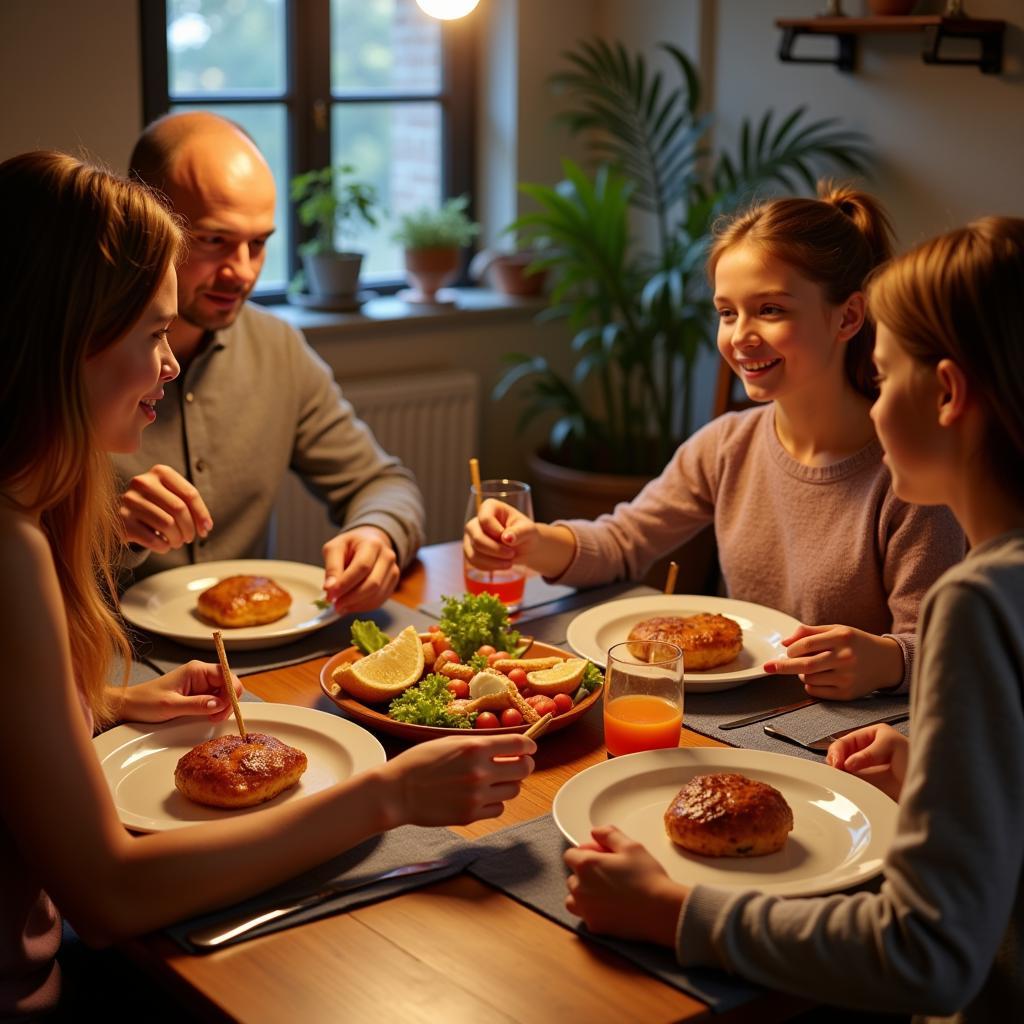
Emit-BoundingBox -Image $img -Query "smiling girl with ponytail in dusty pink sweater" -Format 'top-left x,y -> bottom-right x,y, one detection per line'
464,182 -> 964,700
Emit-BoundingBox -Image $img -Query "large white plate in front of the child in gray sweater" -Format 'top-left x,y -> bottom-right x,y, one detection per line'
552,748 -> 896,896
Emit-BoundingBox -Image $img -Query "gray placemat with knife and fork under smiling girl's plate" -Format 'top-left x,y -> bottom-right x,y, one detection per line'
683,676 -> 908,761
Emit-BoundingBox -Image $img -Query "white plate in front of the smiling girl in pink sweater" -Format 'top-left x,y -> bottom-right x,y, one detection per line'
566,594 -> 800,693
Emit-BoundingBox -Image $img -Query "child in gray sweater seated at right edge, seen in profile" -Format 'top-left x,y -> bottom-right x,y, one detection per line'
565,217 -> 1024,1021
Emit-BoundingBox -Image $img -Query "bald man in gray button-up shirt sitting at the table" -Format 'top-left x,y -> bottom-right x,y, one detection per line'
115,113 -> 423,612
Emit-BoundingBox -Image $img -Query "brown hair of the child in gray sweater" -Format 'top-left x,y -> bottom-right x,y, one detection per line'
867,217 -> 1024,499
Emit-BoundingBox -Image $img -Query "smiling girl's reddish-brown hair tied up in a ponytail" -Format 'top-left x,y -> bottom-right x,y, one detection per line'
708,181 -> 892,398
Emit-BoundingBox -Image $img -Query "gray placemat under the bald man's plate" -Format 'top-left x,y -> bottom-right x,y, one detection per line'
132,601 -> 432,677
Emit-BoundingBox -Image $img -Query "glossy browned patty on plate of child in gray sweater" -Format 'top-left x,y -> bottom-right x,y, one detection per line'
665,772 -> 793,857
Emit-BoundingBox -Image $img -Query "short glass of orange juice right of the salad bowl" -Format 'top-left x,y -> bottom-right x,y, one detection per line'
604,640 -> 683,755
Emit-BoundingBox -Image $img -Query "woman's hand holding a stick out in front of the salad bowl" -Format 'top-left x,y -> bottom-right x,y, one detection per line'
381,733 -> 537,825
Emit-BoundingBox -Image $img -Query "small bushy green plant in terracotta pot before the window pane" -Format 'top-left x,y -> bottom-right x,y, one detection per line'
393,196 -> 480,305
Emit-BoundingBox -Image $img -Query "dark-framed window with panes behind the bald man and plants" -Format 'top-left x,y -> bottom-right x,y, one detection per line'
140,0 -> 473,296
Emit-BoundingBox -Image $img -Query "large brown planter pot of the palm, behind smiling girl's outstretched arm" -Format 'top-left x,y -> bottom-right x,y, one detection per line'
526,453 -> 719,594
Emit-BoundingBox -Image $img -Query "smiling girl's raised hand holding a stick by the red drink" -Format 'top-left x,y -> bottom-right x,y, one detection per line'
462,498 -> 575,577
